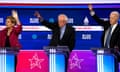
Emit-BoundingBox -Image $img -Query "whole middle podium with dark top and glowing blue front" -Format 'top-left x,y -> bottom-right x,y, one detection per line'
44,46 -> 69,72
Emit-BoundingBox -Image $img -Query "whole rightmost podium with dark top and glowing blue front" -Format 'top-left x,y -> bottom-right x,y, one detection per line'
92,48 -> 119,72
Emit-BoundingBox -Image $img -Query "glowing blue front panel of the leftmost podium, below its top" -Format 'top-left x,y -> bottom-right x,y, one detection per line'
0,54 -> 15,72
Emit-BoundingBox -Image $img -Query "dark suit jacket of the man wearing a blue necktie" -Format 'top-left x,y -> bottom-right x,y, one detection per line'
92,15 -> 120,48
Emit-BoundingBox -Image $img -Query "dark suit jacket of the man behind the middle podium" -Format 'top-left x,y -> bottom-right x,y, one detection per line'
41,20 -> 75,51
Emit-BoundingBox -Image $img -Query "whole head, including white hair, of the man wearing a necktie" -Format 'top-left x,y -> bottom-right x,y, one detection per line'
110,11 -> 120,25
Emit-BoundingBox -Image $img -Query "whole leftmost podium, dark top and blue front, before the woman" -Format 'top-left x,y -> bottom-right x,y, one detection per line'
0,48 -> 19,72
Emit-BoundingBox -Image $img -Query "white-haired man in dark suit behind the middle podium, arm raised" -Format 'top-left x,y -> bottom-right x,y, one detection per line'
35,12 -> 75,72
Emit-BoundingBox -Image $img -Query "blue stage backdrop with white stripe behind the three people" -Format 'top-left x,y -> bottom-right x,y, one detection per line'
0,4 -> 120,50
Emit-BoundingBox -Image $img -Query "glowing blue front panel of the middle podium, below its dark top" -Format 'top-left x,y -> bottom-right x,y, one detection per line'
49,53 -> 65,72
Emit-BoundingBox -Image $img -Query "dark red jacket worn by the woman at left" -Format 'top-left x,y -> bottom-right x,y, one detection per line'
0,25 -> 22,48
